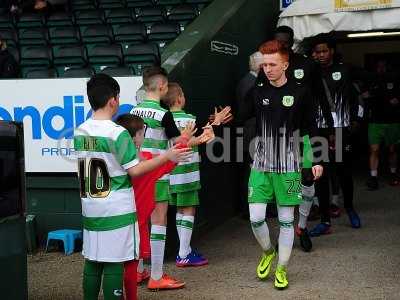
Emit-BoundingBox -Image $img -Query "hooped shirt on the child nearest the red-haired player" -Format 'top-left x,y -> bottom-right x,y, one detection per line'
169,111 -> 201,193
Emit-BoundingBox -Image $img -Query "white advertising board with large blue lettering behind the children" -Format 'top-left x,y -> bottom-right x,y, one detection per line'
0,77 -> 142,173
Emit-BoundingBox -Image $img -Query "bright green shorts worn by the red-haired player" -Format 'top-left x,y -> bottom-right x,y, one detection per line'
248,169 -> 302,206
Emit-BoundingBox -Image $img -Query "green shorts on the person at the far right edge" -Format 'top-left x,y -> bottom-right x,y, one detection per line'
368,123 -> 400,146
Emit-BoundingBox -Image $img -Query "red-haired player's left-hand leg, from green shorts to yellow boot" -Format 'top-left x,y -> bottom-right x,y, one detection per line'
248,170 -> 276,279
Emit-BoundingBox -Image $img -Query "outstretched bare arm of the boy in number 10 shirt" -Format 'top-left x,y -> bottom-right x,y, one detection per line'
127,146 -> 192,177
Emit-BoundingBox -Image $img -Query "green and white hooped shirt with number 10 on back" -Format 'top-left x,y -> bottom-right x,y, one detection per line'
74,119 -> 140,262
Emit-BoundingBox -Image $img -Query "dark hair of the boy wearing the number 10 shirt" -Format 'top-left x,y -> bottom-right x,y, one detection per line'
86,73 -> 120,111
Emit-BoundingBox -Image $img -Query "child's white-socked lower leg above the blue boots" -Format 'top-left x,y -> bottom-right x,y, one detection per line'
179,206 -> 196,258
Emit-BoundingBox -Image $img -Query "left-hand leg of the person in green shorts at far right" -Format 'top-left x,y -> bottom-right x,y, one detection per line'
367,124 -> 384,191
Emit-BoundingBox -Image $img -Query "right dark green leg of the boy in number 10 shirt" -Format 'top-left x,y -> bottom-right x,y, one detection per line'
103,263 -> 123,300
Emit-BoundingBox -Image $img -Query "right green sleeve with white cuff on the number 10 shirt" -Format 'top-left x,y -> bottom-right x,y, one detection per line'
114,130 -> 139,170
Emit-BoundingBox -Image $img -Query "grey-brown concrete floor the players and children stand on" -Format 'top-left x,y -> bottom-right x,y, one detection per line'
28,177 -> 400,300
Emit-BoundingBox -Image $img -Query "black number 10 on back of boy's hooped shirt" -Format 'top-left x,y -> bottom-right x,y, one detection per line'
78,158 -> 111,198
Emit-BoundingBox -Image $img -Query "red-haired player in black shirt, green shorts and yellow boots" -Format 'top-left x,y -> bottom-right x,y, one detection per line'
238,40 -> 322,289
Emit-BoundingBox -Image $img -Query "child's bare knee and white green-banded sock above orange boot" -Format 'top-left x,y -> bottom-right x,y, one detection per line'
150,201 -> 168,280
